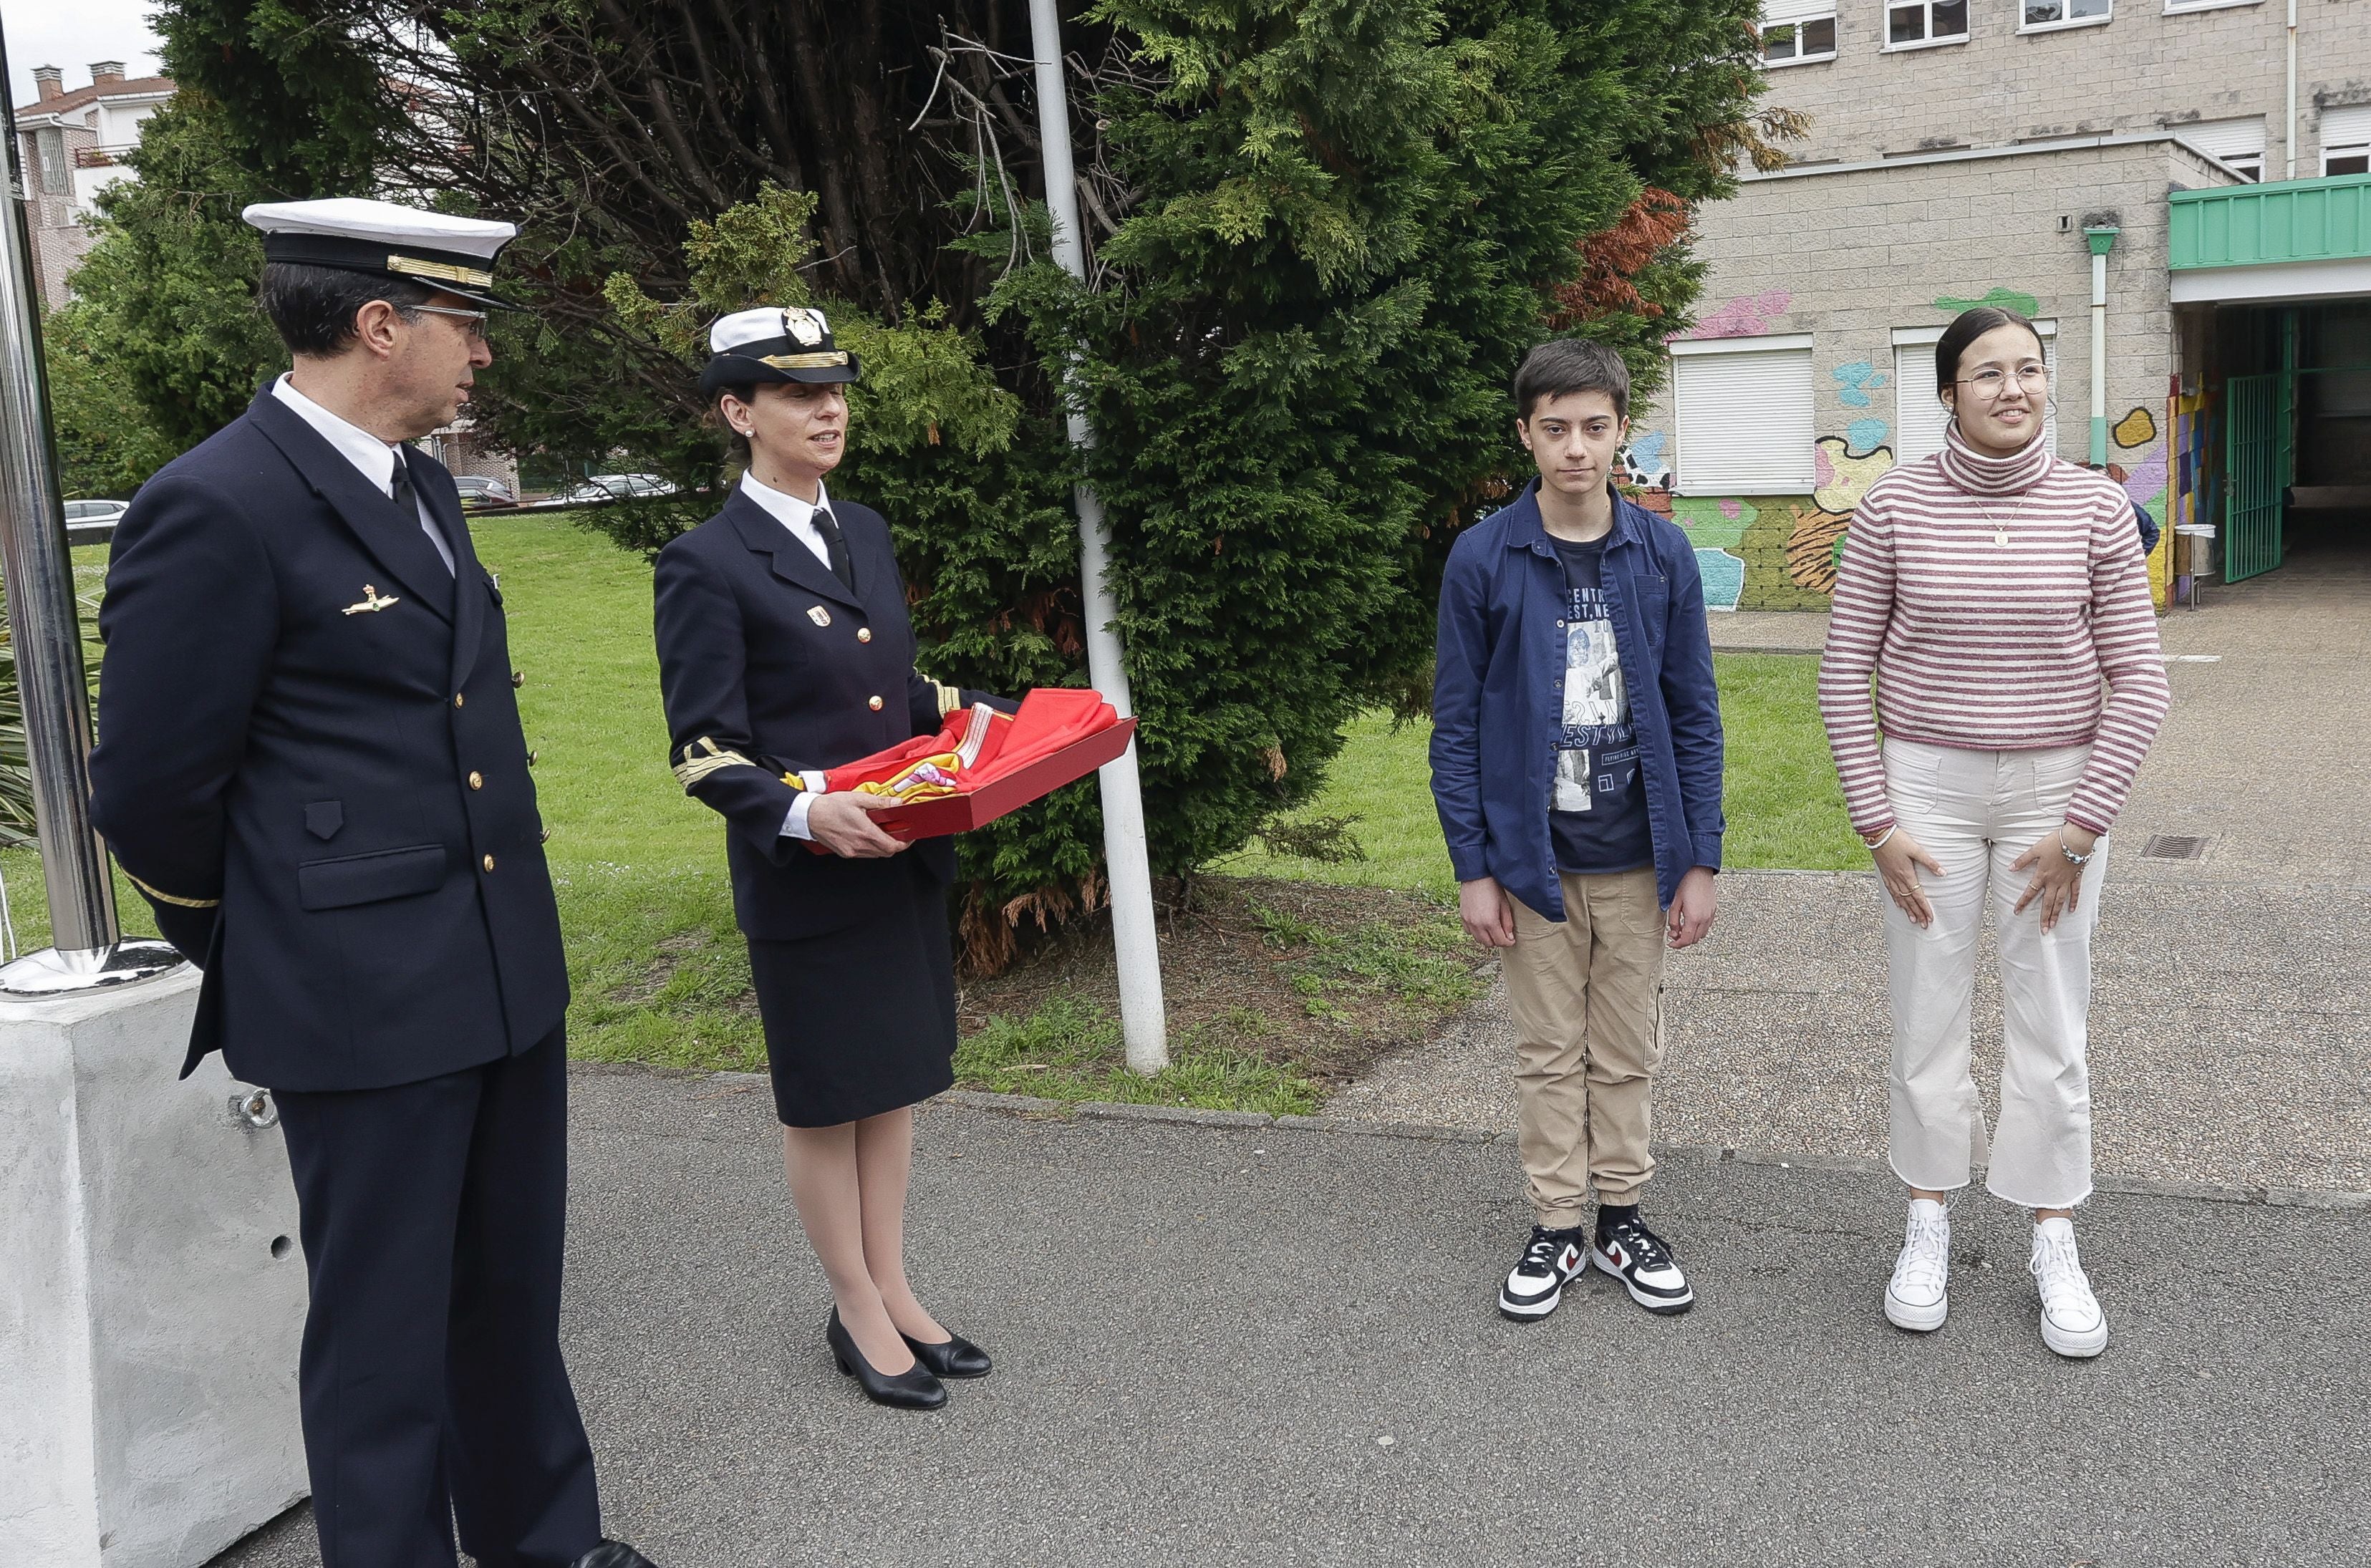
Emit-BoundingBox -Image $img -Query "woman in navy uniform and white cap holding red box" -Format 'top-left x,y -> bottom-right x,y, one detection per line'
657,306 -> 1010,1409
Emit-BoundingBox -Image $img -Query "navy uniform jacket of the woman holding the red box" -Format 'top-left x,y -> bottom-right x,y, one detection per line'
652,486 -> 1013,942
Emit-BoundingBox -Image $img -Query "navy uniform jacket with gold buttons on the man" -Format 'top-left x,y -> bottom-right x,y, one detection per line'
90,389 -> 569,1089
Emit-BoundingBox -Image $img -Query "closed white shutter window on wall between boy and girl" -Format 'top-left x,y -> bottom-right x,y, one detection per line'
1671,332 -> 1814,495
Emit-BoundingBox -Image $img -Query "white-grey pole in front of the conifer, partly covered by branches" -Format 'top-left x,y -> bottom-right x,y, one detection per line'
1013,0 -> 1169,1073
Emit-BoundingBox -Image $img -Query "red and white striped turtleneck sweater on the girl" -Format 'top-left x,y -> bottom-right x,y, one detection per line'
1819,427 -> 2172,838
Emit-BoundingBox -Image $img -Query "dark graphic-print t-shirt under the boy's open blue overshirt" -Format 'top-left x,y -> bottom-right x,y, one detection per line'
1548,538 -> 1655,876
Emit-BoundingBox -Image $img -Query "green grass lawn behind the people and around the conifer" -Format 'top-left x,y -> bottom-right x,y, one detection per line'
0,513 -> 1863,1086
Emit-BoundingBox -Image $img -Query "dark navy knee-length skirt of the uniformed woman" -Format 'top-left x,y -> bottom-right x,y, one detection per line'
749,866 -> 955,1127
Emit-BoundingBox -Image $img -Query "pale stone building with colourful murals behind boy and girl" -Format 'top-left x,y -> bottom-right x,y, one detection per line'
1626,0 -> 2371,607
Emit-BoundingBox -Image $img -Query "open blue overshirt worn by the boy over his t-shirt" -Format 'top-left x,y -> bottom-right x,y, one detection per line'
1432,479 -> 1726,921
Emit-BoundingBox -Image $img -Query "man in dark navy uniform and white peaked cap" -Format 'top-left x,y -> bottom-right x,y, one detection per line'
90,199 -> 647,1568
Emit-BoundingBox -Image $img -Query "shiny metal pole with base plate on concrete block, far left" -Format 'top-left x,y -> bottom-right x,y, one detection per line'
0,38 -> 178,994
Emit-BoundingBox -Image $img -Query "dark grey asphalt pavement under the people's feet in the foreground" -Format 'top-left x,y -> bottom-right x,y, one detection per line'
218,1073 -> 2371,1568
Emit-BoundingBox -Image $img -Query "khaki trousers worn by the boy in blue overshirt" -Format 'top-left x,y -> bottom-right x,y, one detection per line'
1499,866 -> 1664,1229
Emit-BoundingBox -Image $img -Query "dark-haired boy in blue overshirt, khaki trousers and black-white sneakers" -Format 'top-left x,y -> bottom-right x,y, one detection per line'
1432,339 -> 1724,1321
